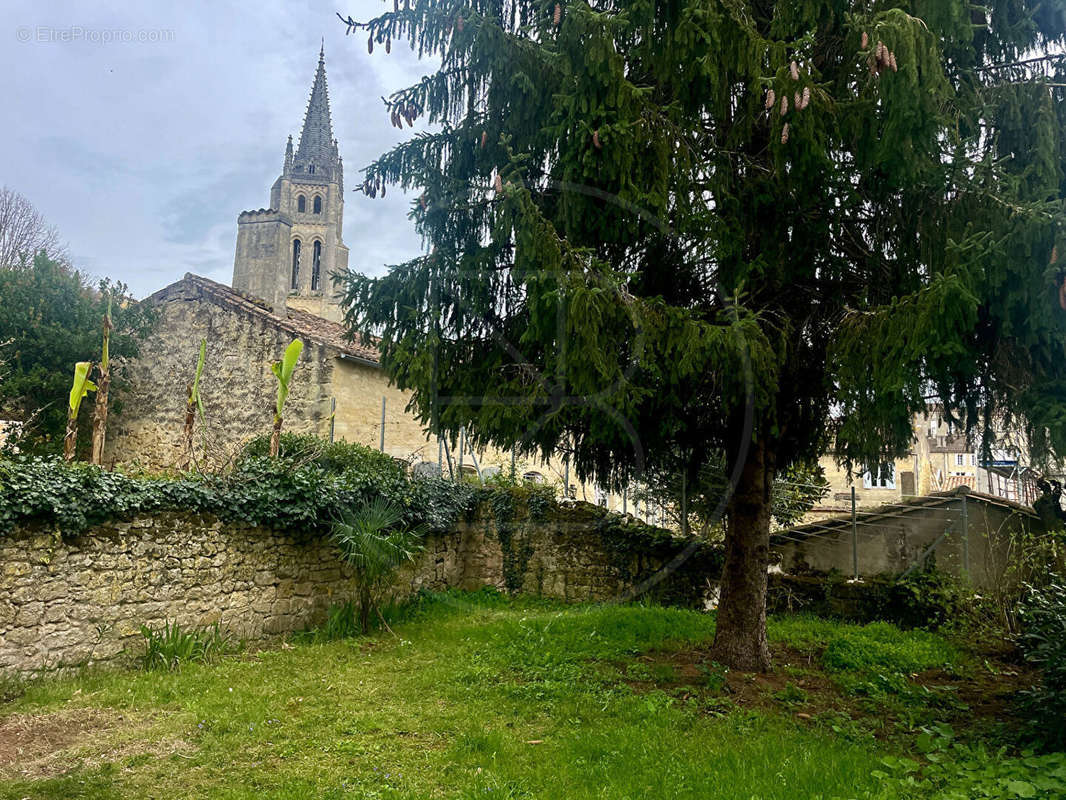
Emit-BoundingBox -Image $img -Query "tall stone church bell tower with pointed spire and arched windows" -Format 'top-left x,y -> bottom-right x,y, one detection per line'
233,47 -> 348,322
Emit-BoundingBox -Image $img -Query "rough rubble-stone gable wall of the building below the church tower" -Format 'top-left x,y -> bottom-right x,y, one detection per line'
106,282 -> 335,468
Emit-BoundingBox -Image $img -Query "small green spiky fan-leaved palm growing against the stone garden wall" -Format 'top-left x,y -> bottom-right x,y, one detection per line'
333,497 -> 429,633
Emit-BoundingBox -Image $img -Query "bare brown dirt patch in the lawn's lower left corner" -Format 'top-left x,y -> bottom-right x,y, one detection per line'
0,708 -> 195,779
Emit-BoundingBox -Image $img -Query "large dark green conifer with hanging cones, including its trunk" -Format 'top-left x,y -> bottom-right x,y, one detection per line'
345,0 -> 1066,669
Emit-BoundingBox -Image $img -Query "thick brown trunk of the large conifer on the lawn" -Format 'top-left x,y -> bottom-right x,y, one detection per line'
712,439 -> 774,672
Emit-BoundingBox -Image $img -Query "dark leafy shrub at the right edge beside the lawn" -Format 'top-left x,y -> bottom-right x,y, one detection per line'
1017,576 -> 1066,749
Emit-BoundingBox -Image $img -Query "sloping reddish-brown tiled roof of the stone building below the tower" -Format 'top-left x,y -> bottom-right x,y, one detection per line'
148,272 -> 379,364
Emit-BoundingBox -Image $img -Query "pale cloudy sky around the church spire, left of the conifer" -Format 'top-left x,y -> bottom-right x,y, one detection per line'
0,0 -> 432,298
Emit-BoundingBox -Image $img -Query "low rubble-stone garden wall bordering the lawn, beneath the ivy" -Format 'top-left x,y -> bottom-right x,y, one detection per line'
0,506 -> 718,672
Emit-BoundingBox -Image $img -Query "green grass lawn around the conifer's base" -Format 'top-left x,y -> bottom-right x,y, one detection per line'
0,592 -> 1053,800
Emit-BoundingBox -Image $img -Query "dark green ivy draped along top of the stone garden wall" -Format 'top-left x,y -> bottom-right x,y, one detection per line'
0,435 -> 480,537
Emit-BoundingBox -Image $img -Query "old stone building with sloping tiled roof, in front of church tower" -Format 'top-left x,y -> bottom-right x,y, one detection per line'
101,274 -> 437,469
